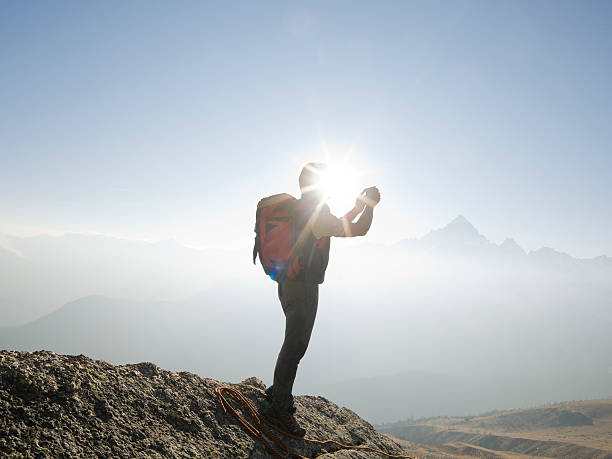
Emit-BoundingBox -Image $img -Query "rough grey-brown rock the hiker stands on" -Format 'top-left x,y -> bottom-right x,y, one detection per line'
0,351 -> 412,458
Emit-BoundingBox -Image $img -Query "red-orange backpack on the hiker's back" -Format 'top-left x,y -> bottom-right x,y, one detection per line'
253,193 -> 304,282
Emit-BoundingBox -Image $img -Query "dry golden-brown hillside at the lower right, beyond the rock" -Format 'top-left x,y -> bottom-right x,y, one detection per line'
377,399 -> 612,459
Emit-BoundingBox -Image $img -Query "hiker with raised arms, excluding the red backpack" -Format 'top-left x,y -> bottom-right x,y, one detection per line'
265,163 -> 380,436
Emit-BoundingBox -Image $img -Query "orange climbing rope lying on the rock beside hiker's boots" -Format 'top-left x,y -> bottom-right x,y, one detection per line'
215,386 -> 416,459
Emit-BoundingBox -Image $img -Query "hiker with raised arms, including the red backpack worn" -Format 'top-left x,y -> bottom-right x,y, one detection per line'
253,163 -> 380,437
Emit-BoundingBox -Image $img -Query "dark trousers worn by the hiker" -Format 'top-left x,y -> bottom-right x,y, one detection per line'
273,281 -> 319,408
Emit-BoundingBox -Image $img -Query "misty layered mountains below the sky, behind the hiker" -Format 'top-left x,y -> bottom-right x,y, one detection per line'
0,216 -> 612,423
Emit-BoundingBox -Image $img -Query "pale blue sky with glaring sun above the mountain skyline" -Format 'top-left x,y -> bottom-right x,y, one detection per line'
0,1 -> 612,256
